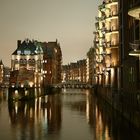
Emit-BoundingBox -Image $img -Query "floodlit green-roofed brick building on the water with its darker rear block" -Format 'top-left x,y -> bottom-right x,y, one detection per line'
10,39 -> 62,87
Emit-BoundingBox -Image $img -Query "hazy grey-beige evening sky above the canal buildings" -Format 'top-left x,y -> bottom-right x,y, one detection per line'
0,0 -> 102,66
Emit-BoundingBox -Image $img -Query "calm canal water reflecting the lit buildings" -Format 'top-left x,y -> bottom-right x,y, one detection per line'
0,89 -> 140,140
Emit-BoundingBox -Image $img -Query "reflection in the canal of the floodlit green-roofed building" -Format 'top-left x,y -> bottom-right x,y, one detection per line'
8,94 -> 61,139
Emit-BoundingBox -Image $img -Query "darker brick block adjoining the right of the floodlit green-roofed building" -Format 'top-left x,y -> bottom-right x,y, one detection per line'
43,40 -> 62,85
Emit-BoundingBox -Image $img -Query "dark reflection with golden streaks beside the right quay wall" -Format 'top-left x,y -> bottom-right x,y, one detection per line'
90,98 -> 140,140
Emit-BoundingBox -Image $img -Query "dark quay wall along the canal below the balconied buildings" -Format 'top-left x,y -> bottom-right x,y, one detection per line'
94,86 -> 140,132
